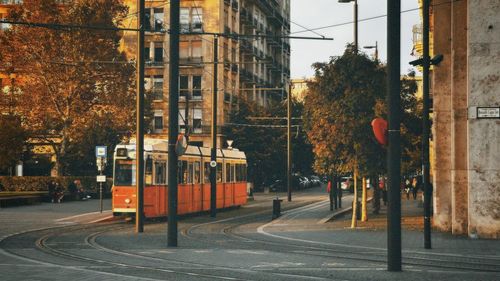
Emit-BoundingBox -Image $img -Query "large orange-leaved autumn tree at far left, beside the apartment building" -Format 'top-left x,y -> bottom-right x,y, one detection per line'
0,0 -> 135,174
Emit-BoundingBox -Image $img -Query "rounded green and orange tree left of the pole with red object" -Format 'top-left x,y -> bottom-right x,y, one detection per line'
305,48 -> 385,226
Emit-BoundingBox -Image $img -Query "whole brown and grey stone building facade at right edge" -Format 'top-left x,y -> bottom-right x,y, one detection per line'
418,0 -> 500,239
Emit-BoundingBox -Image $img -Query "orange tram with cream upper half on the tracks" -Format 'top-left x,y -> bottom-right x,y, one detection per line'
112,139 -> 247,218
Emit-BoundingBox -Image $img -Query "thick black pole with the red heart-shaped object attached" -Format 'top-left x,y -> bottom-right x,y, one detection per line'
387,0 -> 401,271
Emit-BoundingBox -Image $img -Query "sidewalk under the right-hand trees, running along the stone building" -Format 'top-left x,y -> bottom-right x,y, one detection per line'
320,191 -> 500,259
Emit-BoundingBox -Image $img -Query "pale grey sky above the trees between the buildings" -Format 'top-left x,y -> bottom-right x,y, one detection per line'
290,0 -> 420,79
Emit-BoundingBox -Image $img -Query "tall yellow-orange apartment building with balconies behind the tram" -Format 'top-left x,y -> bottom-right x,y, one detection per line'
123,0 -> 290,146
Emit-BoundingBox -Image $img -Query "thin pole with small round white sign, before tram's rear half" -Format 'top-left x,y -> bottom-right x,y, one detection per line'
210,35 -> 219,218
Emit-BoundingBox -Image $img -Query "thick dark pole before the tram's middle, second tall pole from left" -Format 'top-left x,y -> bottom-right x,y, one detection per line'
167,0 -> 180,247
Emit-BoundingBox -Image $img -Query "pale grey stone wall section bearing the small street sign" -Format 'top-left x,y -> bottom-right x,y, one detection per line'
467,0 -> 500,238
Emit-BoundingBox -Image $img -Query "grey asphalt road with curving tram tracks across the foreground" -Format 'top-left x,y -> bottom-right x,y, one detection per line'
0,188 -> 500,281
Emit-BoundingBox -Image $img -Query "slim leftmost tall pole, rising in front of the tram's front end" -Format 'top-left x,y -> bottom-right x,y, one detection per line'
135,0 -> 145,233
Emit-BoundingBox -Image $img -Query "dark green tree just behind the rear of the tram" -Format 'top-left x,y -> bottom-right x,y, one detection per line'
224,96 -> 313,188
